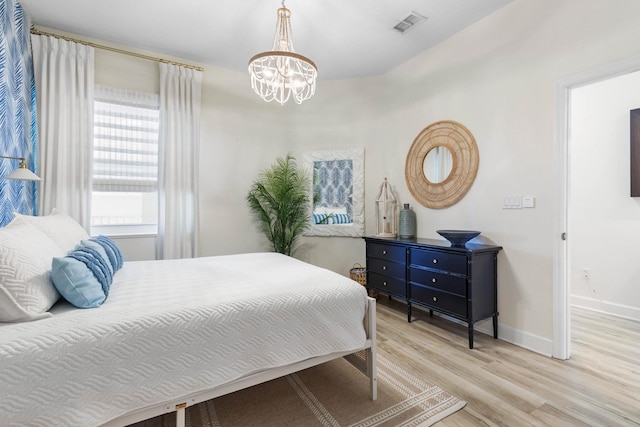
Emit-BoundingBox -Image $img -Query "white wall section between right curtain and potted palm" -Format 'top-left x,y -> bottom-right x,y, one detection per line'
200,67 -> 288,256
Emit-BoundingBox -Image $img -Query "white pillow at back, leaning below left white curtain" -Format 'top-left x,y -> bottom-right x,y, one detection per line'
13,209 -> 89,256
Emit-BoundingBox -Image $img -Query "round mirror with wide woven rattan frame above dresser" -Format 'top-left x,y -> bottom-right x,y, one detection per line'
405,120 -> 480,209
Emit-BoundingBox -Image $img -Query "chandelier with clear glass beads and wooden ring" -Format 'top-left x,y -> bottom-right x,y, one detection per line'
249,0 -> 318,105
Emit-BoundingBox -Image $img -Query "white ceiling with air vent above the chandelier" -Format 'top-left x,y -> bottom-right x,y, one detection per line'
19,0 -> 513,80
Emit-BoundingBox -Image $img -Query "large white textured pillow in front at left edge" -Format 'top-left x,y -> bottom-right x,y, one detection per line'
0,220 -> 66,322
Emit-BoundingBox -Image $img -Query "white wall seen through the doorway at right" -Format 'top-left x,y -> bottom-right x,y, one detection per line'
569,72 -> 640,320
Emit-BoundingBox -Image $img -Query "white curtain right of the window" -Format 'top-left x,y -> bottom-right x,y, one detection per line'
156,63 -> 202,259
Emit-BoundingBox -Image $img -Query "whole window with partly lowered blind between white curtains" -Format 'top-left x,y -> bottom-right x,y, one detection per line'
91,86 -> 160,235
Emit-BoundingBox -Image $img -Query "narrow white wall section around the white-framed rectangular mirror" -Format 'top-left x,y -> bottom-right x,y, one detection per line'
288,78 -> 384,275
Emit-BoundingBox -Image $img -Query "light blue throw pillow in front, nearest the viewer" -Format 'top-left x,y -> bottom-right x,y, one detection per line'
51,245 -> 113,308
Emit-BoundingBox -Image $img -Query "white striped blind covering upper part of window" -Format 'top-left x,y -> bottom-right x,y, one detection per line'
93,86 -> 160,192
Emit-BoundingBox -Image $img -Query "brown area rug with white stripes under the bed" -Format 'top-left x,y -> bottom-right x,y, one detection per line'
135,356 -> 466,427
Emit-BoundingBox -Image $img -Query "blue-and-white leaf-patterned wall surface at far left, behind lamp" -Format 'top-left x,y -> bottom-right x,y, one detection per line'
0,0 -> 36,226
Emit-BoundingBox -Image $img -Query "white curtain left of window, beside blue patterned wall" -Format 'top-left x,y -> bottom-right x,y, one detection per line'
31,35 -> 94,230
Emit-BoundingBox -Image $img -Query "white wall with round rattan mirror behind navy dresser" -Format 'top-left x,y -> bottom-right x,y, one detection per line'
292,0 -> 640,354
